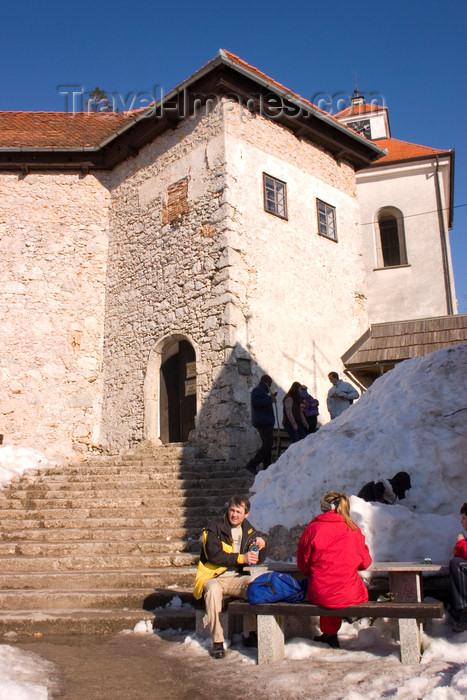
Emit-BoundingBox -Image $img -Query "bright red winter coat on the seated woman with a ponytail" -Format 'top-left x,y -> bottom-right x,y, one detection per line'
297,510 -> 371,608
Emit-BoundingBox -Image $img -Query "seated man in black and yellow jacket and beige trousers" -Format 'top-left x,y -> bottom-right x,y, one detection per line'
193,496 -> 266,659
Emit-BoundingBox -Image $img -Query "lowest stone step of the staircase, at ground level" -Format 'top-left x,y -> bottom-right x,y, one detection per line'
0,608 -> 195,635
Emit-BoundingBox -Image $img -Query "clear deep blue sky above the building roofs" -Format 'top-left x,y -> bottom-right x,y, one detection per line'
0,0 -> 467,312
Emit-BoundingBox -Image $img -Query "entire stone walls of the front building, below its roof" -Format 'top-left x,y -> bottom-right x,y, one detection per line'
0,103 -> 368,462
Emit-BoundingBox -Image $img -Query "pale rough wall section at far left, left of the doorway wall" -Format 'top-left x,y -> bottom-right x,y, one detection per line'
0,173 -> 109,454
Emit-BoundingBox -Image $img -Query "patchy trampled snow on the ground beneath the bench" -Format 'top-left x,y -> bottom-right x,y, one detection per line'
122,615 -> 467,700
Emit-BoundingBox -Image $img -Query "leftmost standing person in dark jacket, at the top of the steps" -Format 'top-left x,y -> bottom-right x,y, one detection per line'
246,374 -> 276,474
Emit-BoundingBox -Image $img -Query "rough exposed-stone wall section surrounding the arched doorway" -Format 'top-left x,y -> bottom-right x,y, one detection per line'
100,101 -> 252,457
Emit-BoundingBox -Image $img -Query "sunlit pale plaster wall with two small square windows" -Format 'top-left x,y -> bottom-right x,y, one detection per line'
226,105 -> 368,422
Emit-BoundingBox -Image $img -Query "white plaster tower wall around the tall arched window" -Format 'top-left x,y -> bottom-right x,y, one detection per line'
357,157 -> 455,323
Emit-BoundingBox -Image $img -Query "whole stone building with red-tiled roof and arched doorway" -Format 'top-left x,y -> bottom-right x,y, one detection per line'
0,51 -> 455,460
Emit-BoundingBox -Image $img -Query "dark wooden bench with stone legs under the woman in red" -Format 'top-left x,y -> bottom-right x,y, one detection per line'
228,600 -> 443,664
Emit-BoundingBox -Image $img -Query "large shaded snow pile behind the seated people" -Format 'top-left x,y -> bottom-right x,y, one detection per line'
251,344 -> 467,561
